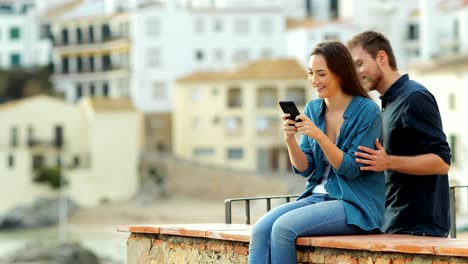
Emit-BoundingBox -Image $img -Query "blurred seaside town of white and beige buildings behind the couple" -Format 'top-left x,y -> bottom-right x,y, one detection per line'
0,0 -> 468,263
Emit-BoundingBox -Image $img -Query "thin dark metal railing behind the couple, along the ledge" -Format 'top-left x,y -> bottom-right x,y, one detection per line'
224,185 -> 468,238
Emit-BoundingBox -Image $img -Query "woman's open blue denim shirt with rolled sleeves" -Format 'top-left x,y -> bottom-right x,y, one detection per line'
293,96 -> 385,230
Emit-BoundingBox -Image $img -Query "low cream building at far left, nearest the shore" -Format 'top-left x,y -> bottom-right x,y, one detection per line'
0,96 -> 141,212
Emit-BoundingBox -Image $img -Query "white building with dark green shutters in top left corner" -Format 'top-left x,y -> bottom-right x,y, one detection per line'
0,0 -> 51,69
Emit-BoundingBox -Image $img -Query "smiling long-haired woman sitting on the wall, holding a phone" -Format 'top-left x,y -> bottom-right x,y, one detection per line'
249,42 -> 385,264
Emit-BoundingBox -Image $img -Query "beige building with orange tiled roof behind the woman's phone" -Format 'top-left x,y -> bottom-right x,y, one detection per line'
172,59 -> 315,172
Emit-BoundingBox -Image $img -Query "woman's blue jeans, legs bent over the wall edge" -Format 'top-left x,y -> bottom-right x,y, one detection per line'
249,194 -> 368,264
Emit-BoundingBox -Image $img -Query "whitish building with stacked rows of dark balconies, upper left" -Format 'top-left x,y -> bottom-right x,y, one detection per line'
43,0 -> 131,102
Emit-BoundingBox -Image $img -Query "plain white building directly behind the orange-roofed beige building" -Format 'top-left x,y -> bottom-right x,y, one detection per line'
132,3 -> 286,113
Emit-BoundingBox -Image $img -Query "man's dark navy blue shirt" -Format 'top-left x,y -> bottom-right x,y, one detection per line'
381,74 -> 451,235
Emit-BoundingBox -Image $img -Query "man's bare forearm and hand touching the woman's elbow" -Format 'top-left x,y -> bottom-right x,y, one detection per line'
355,139 -> 449,175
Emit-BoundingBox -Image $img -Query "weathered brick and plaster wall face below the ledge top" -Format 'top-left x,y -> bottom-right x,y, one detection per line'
127,233 -> 468,264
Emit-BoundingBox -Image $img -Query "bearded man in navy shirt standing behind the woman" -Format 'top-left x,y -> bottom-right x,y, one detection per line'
348,31 -> 451,237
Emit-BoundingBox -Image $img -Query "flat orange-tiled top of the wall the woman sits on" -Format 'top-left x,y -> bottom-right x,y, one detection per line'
117,223 -> 468,257
